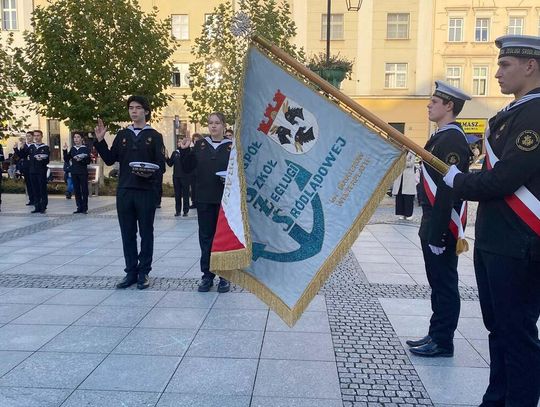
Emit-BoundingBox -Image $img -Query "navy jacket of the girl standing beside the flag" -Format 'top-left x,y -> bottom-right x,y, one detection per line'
181,137 -> 232,204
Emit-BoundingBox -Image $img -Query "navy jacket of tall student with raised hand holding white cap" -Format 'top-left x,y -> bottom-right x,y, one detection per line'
94,125 -> 165,190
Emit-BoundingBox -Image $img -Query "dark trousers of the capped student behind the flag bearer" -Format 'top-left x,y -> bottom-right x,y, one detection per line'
421,239 -> 460,350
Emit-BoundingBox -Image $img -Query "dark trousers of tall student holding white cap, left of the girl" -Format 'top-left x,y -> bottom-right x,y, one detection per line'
116,188 -> 156,275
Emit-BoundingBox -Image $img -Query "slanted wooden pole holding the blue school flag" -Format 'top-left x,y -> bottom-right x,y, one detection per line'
251,35 -> 448,174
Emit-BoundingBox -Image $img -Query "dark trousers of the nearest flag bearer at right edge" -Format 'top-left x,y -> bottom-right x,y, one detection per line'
474,249 -> 540,407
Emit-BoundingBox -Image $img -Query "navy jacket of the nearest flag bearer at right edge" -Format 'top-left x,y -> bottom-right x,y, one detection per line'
454,88 -> 540,261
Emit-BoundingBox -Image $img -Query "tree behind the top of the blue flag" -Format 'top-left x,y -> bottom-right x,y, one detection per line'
184,0 -> 304,124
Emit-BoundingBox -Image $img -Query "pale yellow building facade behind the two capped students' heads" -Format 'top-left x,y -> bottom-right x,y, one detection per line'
433,0 -> 540,137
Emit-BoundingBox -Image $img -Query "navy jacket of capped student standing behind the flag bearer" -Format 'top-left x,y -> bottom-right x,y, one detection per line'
417,122 -> 471,247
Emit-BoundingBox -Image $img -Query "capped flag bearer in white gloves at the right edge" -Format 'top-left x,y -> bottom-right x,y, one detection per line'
444,35 -> 540,407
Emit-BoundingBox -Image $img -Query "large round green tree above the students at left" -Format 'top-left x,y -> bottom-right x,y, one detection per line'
14,0 -> 174,130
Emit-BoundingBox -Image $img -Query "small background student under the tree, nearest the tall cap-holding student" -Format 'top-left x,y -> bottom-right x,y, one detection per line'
63,133 -> 90,214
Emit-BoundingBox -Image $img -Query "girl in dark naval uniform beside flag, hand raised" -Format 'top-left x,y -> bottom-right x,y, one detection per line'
180,112 -> 232,293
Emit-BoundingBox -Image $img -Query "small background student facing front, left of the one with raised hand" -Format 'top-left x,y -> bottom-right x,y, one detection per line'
28,130 -> 50,213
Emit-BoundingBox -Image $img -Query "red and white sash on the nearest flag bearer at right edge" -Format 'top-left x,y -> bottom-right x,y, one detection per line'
485,135 -> 540,236
